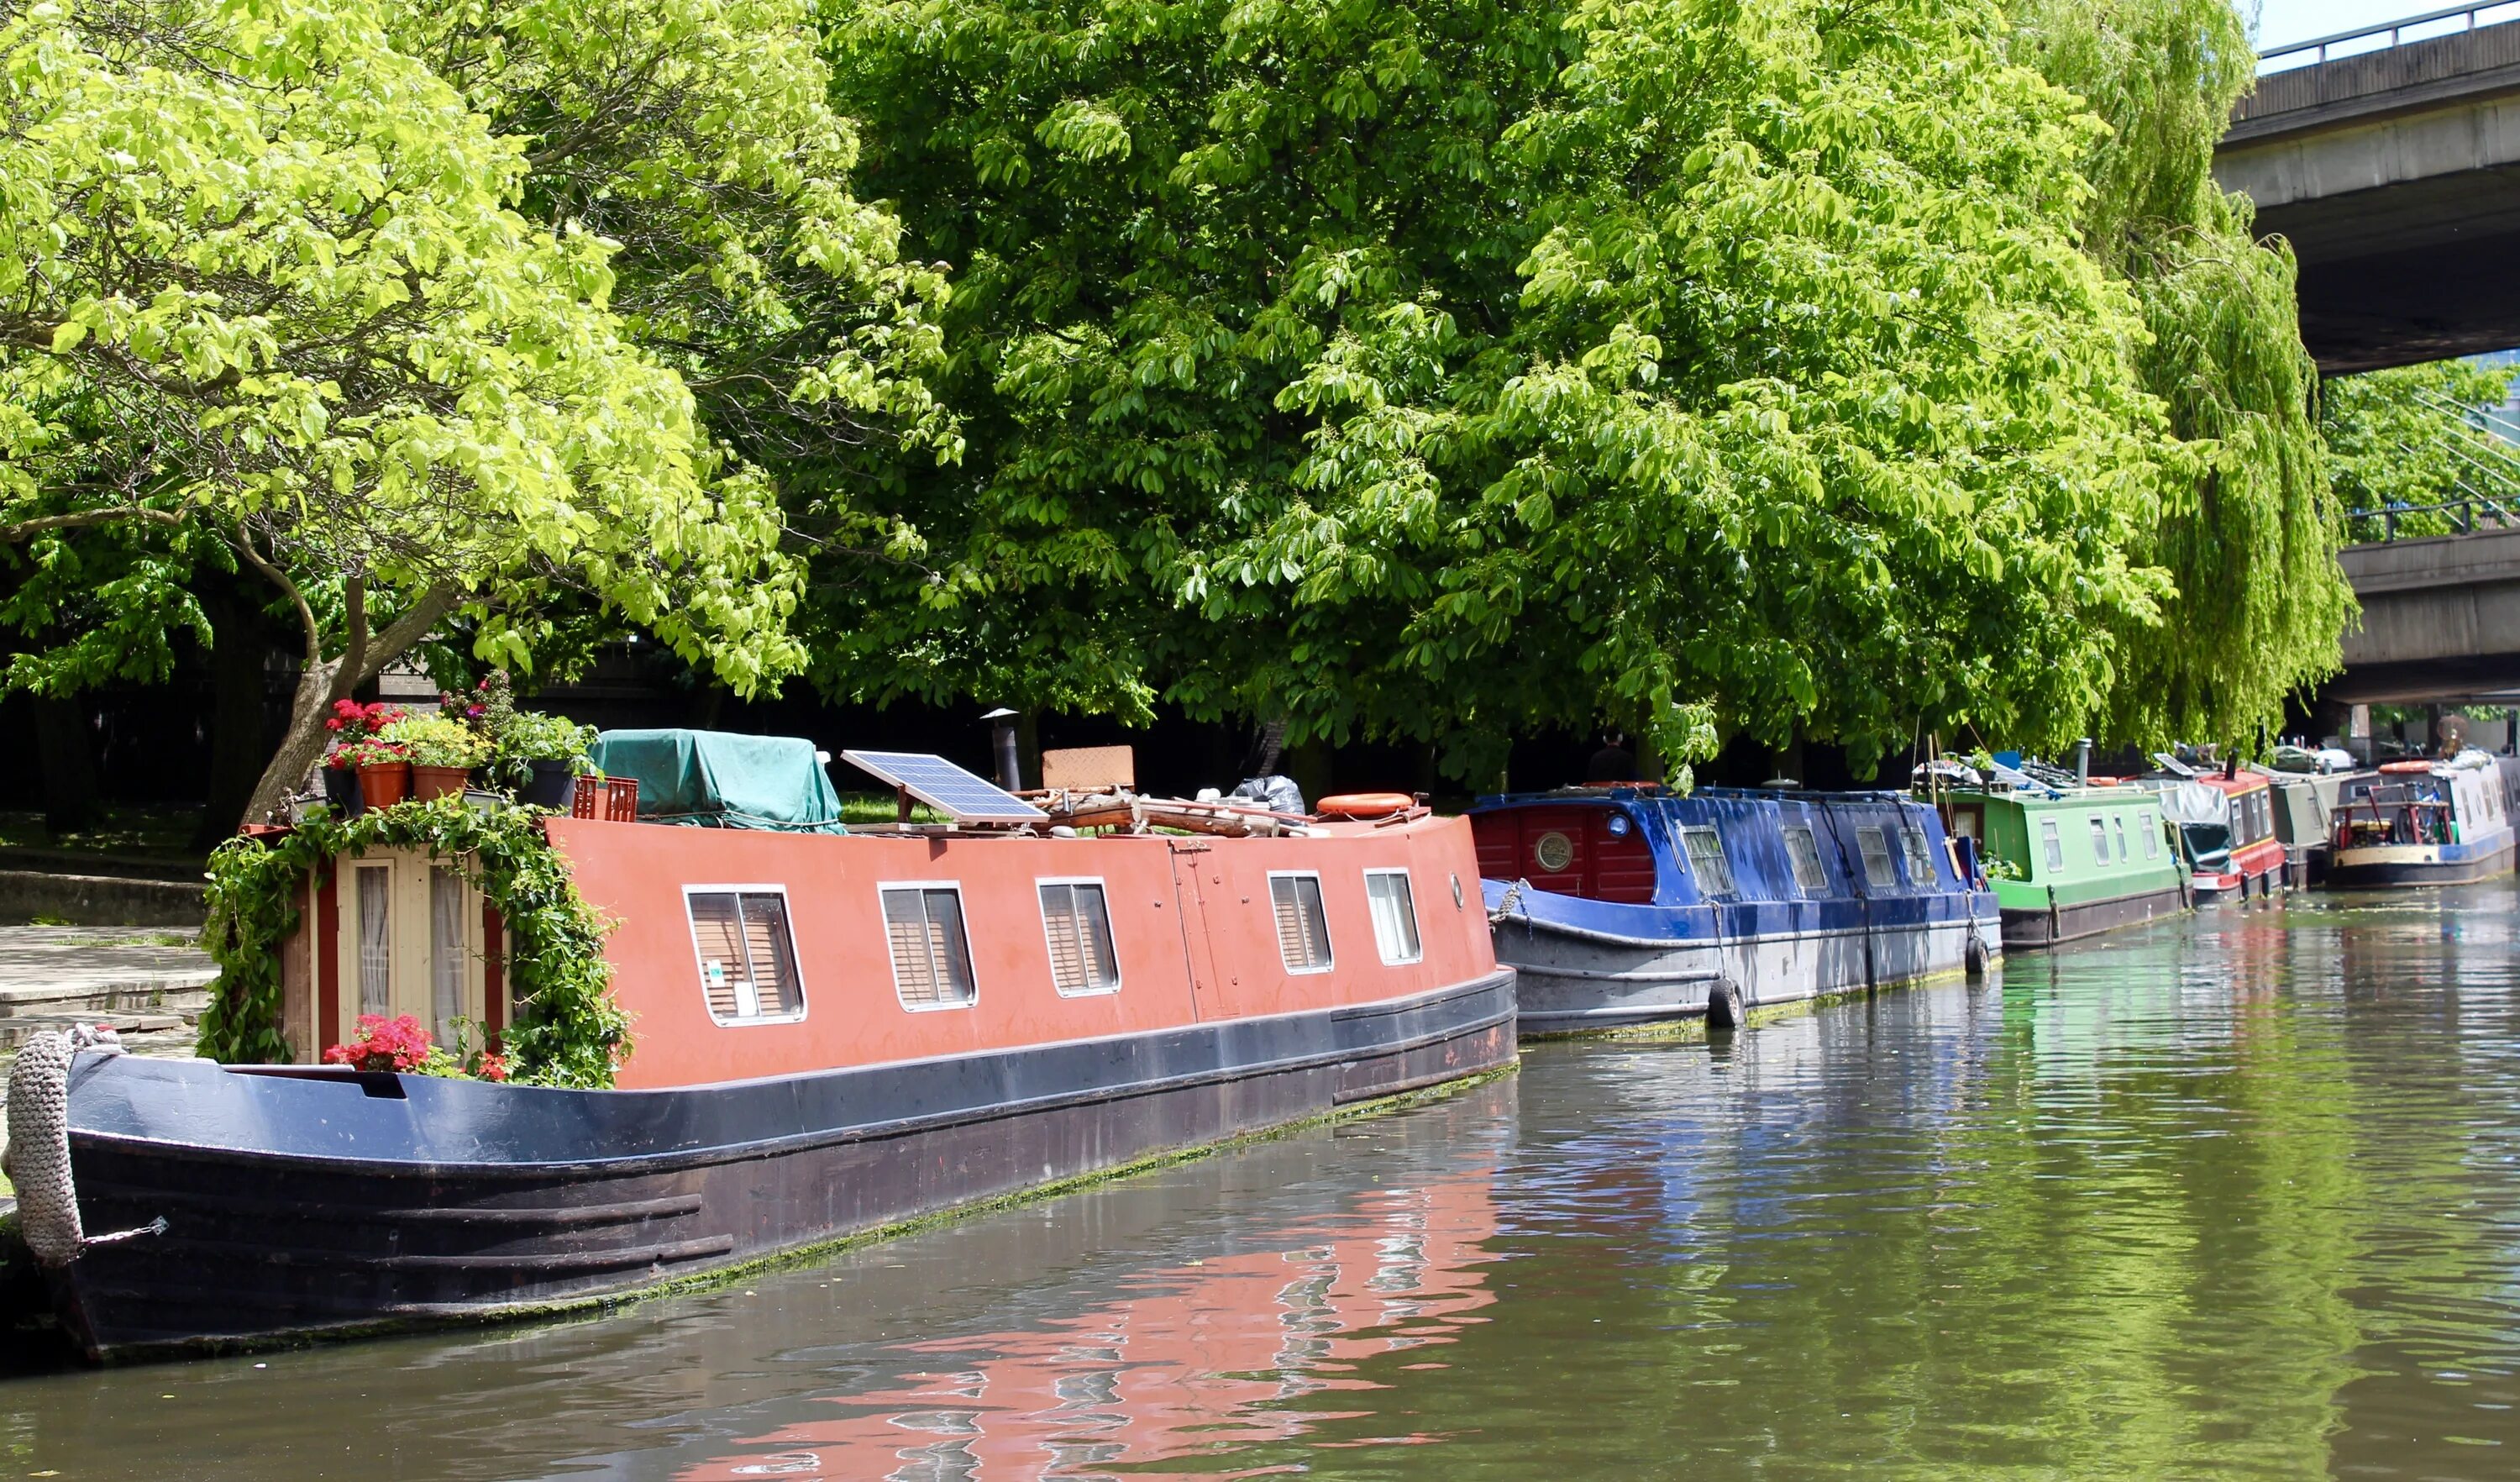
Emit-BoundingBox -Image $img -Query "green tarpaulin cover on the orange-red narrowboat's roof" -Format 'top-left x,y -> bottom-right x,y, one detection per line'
595,731 -> 849,834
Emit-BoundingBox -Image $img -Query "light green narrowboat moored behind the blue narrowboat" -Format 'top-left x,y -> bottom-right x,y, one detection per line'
1935,781 -> 2187,953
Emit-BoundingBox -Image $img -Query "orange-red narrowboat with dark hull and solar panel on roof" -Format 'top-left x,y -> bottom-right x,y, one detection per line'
24,738 -> 1515,1358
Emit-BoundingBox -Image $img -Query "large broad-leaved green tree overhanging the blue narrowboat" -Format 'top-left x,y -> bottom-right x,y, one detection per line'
814,0 -> 2187,776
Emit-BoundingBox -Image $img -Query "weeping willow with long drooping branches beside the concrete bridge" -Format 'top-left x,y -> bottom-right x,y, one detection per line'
2006,0 -> 2354,744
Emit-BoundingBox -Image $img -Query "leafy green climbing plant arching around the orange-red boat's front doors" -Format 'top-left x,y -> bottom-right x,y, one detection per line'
202,799 -> 630,1086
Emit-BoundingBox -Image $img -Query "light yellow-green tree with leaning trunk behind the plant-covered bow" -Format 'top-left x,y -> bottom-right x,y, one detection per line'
0,0 -> 799,812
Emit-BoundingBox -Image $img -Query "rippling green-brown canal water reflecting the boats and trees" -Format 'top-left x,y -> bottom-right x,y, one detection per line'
14,882 -> 2520,1482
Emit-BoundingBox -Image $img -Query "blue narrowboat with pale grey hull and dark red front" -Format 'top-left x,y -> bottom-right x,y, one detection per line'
1469,786 -> 2003,1036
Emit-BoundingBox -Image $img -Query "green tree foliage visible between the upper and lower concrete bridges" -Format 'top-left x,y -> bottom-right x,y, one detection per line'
2318,360 -> 2520,539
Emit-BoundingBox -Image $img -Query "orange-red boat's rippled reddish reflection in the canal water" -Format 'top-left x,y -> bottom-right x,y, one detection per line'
683,1180 -> 1497,1482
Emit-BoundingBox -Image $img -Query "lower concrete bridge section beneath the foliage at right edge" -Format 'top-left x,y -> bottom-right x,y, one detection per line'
2321,504 -> 2520,706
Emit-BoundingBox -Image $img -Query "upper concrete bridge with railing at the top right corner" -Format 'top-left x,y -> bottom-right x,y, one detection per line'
2215,0 -> 2520,376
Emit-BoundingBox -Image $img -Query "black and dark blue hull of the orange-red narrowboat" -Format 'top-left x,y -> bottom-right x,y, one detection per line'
55,968 -> 1515,1358
